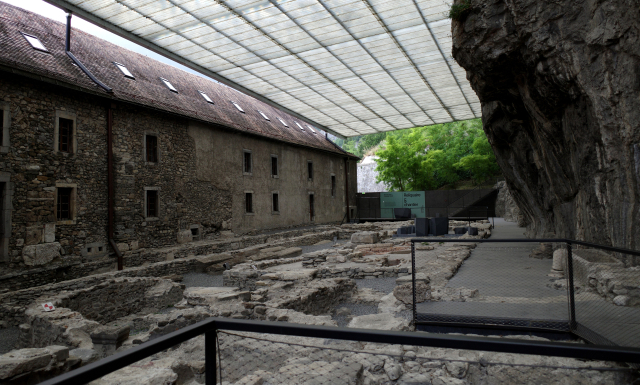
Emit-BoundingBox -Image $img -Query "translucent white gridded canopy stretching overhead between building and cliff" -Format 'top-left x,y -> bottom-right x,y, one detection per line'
47,0 -> 481,136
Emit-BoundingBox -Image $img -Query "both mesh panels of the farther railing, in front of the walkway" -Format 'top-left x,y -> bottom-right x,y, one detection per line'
412,239 -> 640,348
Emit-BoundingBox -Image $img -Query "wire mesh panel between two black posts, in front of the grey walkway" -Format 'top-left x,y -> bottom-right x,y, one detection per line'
414,234 -> 569,332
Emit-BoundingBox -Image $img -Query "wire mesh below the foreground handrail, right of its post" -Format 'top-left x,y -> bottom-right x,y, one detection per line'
218,331 -> 638,385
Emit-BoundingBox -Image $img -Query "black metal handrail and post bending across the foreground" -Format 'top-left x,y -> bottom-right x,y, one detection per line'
41,318 -> 640,385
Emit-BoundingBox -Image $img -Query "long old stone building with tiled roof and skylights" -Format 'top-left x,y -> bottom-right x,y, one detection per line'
0,3 -> 358,271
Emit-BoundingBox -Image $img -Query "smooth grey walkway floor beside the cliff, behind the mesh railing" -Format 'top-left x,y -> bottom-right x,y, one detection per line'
416,219 -> 640,347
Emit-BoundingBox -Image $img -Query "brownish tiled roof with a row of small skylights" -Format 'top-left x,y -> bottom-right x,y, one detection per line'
0,2 -> 355,157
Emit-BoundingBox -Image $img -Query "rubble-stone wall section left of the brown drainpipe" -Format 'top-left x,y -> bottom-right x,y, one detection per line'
0,76 -> 107,269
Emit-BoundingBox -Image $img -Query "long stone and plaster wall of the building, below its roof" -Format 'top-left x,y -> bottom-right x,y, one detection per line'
0,76 -> 356,276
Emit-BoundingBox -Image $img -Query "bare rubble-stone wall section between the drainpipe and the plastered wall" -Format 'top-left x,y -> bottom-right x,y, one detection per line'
111,104 -> 232,251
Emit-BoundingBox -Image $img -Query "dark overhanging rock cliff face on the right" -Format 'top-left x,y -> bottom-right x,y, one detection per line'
452,0 -> 640,254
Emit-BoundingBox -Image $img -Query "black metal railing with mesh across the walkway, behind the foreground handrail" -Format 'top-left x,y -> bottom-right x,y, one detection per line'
411,238 -> 640,348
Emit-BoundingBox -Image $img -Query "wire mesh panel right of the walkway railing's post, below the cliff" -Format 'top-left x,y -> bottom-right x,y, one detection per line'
568,246 -> 640,347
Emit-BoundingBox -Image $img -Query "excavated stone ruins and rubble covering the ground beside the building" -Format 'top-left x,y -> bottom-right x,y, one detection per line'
0,222 -> 630,385
